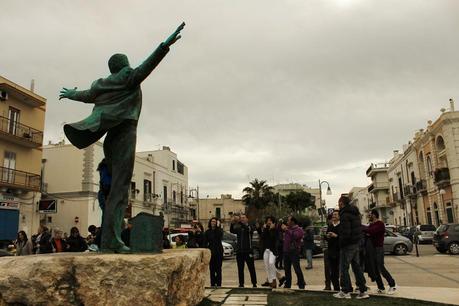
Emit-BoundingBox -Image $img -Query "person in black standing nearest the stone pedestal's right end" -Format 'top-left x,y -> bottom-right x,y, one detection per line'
204,217 -> 223,287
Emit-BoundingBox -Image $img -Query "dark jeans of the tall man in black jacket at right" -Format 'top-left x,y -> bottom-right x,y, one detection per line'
340,243 -> 367,293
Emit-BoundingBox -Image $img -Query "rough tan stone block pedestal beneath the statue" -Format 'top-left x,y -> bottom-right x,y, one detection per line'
0,249 -> 210,306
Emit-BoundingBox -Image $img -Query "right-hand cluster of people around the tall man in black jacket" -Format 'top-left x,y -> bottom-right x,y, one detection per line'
324,196 -> 397,299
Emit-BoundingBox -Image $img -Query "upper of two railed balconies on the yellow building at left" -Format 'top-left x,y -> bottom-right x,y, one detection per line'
0,116 -> 43,148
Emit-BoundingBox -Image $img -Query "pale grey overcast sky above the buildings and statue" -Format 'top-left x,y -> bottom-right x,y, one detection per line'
0,0 -> 459,206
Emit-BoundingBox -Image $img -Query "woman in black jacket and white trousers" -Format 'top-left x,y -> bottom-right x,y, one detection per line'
261,216 -> 278,288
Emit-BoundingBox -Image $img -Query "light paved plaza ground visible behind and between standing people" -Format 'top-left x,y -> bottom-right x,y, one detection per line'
207,245 -> 459,305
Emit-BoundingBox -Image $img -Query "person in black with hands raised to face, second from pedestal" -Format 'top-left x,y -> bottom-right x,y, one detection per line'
230,214 -> 257,288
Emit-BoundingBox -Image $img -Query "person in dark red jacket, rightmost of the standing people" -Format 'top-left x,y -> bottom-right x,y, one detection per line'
364,209 -> 397,294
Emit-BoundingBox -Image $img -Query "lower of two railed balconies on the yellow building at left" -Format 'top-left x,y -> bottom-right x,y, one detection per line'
0,167 -> 41,191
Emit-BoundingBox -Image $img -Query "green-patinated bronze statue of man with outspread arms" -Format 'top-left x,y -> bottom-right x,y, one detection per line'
59,23 -> 185,253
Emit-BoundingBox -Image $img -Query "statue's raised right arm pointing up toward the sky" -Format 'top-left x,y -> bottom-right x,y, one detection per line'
129,22 -> 185,86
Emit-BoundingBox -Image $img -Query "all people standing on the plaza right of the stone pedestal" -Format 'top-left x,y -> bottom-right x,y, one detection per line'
203,196 -> 397,299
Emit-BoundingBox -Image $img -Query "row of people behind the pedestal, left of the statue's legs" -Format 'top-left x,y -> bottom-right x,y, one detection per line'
14,225 -> 104,256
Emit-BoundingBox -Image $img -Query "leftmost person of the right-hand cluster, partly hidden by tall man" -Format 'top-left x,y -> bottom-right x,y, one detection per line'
326,210 -> 340,291
